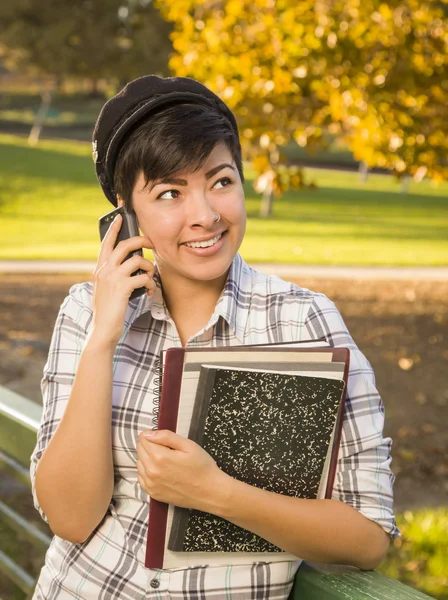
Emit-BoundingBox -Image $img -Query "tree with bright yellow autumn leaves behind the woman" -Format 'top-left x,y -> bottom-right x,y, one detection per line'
157,0 -> 448,214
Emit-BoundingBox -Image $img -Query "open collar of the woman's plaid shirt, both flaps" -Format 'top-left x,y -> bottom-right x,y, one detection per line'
125,254 -> 252,344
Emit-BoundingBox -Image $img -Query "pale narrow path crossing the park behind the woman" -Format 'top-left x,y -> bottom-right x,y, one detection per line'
0,260 -> 448,281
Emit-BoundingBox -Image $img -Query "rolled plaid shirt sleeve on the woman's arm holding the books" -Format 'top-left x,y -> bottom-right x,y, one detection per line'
305,294 -> 400,539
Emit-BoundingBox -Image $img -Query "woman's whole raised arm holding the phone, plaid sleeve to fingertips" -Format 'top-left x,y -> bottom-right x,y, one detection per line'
32,217 -> 155,543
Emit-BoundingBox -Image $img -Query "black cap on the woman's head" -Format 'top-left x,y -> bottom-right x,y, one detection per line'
92,75 -> 238,206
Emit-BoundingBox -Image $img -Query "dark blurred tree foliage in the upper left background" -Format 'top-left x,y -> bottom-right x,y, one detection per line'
0,0 -> 172,86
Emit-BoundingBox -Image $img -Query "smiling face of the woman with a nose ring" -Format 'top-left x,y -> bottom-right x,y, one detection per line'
132,143 -> 246,288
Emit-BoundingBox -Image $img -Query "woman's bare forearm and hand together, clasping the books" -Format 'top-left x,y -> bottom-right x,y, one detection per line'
137,430 -> 389,569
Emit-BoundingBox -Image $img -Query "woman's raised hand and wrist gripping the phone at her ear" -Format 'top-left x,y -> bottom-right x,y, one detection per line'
92,215 -> 156,345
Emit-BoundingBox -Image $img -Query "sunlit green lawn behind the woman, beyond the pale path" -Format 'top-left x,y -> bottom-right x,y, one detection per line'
0,135 -> 448,266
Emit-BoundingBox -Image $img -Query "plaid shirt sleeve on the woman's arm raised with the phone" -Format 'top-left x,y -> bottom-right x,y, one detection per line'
30,283 -> 92,523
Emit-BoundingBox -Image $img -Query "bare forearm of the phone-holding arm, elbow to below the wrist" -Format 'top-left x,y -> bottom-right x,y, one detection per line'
35,337 -> 114,543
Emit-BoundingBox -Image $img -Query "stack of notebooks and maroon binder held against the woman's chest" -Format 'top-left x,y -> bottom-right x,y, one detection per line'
145,340 -> 350,569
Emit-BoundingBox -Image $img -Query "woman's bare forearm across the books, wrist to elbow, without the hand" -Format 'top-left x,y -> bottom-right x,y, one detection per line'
211,476 -> 389,569
